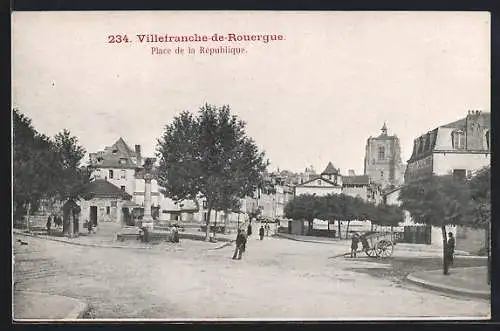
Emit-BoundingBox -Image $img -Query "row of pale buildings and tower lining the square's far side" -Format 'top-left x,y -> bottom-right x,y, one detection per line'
57,111 -> 490,246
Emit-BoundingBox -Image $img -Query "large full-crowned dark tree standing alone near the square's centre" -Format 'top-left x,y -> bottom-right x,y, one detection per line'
157,104 -> 268,240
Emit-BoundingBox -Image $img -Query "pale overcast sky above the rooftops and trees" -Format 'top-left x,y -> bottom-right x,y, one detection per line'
12,12 -> 490,174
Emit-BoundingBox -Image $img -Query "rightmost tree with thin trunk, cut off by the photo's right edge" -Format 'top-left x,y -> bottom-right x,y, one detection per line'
468,166 -> 491,284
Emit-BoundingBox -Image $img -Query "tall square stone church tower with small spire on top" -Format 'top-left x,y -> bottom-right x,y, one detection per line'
364,123 -> 406,189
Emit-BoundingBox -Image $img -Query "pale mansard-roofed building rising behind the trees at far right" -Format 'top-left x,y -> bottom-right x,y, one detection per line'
405,111 -> 491,182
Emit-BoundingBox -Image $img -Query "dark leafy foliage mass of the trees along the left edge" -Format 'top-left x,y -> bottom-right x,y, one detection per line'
13,109 -> 89,224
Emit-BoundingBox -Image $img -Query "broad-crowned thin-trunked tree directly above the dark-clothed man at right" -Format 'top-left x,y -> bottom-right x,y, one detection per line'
399,176 -> 470,275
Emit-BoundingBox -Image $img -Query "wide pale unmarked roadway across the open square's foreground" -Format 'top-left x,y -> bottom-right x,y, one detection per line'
14,236 -> 490,319
